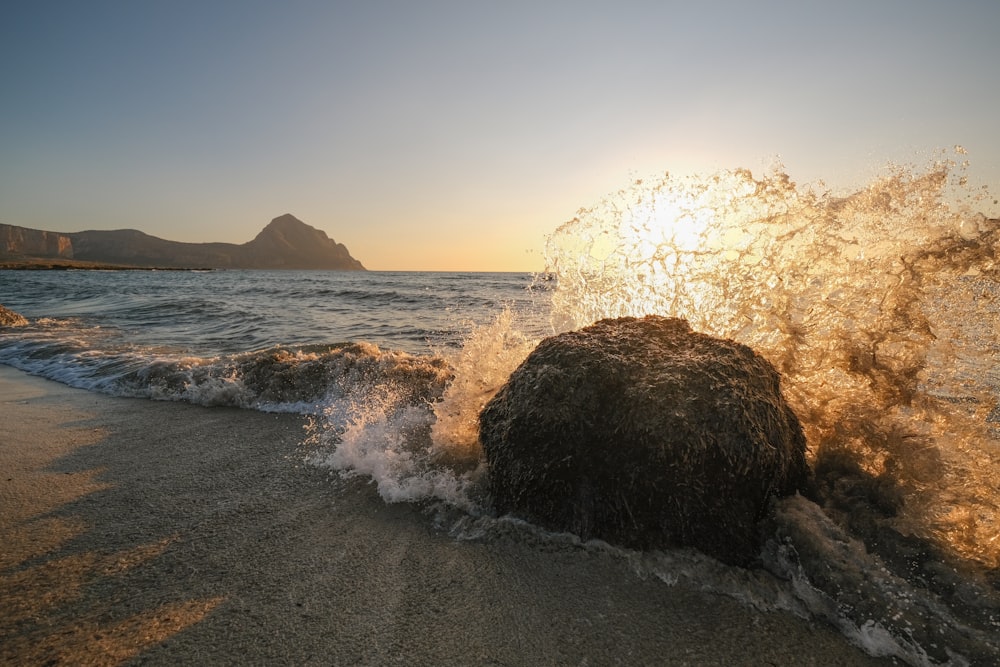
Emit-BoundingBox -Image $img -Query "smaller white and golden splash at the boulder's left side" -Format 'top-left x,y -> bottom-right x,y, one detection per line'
311,308 -> 538,513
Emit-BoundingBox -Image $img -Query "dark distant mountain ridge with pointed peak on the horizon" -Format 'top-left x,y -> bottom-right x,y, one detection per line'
0,213 -> 365,271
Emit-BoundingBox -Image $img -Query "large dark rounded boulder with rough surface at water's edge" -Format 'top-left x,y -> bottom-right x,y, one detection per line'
479,316 -> 808,564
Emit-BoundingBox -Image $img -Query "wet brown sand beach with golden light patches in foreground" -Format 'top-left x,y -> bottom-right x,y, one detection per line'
0,366 -> 894,665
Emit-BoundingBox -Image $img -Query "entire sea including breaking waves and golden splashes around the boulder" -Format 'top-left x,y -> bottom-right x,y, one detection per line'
0,158 -> 1000,665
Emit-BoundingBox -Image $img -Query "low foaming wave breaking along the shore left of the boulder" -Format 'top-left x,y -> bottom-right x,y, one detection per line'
0,318 -> 452,418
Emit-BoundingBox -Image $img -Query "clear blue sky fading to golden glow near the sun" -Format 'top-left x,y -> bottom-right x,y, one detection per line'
0,0 -> 1000,271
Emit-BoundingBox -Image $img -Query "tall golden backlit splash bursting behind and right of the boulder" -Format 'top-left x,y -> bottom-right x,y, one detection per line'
546,150 -> 1000,568
